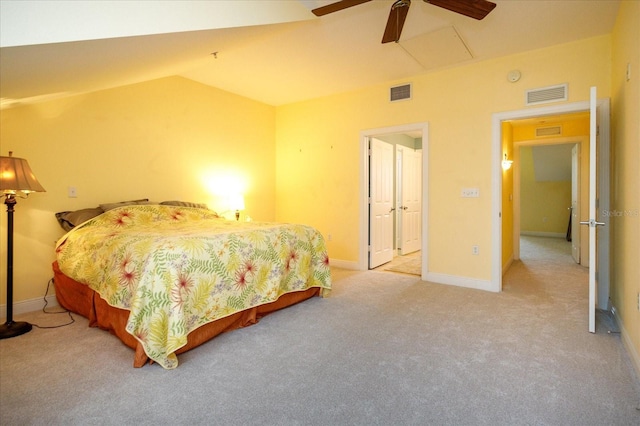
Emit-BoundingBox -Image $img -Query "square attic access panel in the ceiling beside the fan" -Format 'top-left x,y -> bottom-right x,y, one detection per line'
398,27 -> 473,70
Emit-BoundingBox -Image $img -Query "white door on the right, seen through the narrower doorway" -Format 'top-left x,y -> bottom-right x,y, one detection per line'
398,148 -> 422,255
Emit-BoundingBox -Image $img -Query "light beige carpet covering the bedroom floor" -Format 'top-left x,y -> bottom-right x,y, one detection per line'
0,238 -> 640,425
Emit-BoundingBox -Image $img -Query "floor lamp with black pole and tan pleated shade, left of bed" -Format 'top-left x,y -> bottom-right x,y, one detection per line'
0,151 -> 45,339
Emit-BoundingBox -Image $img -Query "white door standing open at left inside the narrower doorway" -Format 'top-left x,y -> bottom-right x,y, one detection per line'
369,138 -> 394,269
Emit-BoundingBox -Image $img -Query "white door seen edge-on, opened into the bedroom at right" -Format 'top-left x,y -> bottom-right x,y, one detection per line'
580,87 -> 609,333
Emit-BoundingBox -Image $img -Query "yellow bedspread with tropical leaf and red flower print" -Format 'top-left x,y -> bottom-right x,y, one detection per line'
56,205 -> 331,369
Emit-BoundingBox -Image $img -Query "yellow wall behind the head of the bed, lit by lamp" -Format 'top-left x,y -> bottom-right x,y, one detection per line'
0,77 -> 275,304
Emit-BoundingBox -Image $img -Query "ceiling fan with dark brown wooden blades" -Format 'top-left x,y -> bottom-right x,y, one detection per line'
312,0 -> 496,43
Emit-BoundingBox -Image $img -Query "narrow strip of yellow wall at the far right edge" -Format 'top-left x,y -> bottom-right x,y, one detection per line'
610,1 -> 640,375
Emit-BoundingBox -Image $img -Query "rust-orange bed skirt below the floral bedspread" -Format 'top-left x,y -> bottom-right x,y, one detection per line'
53,261 -> 321,367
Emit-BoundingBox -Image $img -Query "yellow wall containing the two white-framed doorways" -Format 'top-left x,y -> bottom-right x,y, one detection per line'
276,36 -> 611,280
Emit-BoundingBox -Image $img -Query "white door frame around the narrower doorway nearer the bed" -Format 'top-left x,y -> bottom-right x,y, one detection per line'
358,122 -> 429,279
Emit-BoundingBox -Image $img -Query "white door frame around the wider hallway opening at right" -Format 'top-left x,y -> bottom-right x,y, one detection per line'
491,98 -> 611,292
